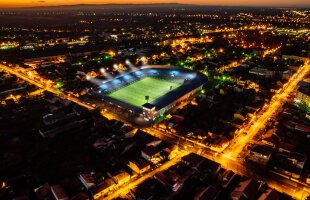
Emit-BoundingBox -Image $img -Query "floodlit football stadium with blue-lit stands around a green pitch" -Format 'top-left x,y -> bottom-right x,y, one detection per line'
89,65 -> 208,121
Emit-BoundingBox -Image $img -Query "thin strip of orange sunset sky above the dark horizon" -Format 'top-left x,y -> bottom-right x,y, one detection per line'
0,0 -> 310,8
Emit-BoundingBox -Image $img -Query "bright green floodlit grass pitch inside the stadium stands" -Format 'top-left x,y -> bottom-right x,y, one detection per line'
107,77 -> 181,107
